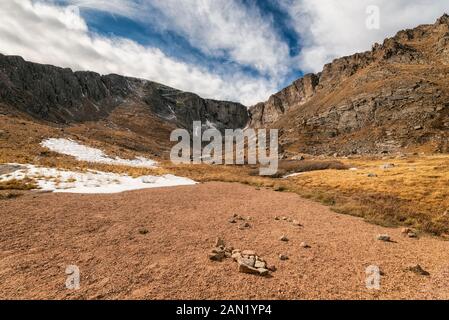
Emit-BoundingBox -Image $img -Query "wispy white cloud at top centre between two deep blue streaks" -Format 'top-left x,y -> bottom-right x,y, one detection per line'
65,0 -> 291,77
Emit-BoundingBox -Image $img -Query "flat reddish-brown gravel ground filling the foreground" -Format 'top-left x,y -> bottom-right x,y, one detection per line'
0,183 -> 449,299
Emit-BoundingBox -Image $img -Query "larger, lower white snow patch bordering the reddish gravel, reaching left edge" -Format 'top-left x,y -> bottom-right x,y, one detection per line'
0,164 -> 196,194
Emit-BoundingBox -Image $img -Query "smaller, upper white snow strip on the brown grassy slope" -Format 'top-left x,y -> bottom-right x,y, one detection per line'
41,138 -> 157,168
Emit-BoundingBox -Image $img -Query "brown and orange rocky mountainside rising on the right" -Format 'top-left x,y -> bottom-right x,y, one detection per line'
250,14 -> 449,155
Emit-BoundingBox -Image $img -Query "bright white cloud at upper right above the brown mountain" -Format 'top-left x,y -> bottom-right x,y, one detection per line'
281,0 -> 449,72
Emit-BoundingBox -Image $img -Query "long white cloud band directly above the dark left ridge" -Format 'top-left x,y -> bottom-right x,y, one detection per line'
0,0 -> 276,105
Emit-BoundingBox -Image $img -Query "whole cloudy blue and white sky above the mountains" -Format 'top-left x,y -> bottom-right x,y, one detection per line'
0,0 -> 449,106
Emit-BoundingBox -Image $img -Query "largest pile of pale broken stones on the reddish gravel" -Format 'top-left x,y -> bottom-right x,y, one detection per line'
208,238 -> 276,277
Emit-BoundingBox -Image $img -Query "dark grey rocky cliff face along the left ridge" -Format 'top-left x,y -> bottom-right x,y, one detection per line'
0,54 -> 248,128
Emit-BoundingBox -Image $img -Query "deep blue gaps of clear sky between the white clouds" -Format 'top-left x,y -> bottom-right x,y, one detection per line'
81,0 -> 303,87
